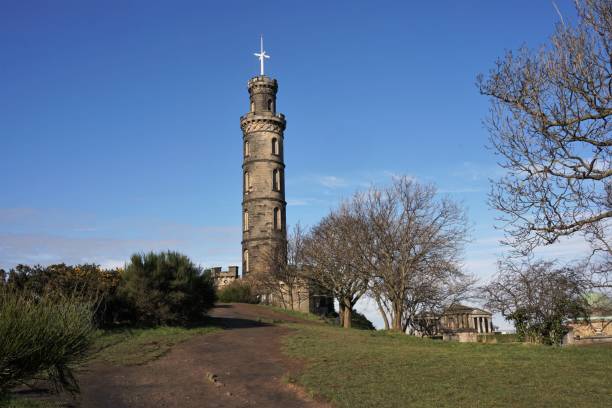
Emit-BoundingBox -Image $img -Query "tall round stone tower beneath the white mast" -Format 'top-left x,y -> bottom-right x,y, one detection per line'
240,75 -> 287,276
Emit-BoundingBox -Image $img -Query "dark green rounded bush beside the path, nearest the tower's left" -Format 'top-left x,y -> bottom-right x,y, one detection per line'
118,251 -> 215,324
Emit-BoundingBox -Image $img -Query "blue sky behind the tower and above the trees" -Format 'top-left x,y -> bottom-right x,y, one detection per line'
0,0 -> 584,326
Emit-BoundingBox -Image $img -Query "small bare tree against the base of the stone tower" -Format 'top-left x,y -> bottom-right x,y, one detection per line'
249,224 -> 308,310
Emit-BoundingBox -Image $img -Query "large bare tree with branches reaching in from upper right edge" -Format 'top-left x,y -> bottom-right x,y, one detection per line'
478,0 -> 612,264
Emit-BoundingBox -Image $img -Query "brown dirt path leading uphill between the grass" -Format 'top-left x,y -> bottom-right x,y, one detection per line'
70,304 -> 327,408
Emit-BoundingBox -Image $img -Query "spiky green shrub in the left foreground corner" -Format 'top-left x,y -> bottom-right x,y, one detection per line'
0,287 -> 94,395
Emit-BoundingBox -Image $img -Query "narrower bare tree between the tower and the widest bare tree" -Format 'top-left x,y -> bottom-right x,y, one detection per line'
305,205 -> 369,328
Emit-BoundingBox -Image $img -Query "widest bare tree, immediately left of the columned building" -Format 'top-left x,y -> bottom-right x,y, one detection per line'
352,177 -> 473,331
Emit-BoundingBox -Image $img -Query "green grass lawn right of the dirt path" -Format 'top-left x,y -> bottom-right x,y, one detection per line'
284,324 -> 612,407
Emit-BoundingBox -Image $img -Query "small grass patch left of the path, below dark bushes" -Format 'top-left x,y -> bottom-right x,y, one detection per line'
90,326 -> 220,365
